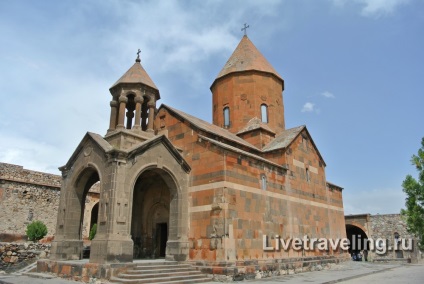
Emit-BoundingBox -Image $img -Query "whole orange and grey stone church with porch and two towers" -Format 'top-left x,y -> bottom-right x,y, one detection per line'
50,35 -> 346,274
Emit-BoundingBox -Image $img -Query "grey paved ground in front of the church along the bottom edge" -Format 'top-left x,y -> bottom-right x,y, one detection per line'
0,261 -> 424,284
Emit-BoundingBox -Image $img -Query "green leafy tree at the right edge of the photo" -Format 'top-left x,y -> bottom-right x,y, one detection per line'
401,137 -> 424,249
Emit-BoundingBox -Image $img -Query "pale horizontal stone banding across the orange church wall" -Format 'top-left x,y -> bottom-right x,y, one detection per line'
188,181 -> 344,213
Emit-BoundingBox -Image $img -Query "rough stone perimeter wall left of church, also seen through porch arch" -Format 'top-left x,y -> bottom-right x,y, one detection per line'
0,163 -> 99,241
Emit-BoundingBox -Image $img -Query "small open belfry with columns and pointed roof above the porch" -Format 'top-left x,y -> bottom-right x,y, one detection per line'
108,50 -> 160,134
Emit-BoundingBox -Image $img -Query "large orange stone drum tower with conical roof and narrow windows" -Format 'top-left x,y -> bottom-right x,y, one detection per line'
210,34 -> 285,139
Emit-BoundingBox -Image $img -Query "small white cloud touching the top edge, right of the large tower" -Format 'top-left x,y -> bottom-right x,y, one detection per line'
332,0 -> 410,17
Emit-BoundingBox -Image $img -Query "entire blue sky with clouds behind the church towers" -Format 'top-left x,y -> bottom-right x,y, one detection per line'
0,0 -> 424,214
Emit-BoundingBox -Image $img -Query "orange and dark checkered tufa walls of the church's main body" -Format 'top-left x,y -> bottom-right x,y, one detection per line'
156,108 -> 346,268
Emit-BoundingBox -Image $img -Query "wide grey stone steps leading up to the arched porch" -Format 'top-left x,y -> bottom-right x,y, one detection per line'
110,261 -> 212,284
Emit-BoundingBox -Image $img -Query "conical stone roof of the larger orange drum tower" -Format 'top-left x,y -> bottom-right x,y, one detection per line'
215,35 -> 283,81
